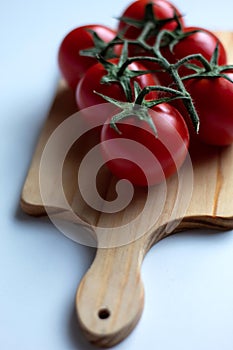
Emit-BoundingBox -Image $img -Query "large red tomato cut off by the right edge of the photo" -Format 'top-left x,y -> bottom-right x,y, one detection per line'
185,71 -> 233,146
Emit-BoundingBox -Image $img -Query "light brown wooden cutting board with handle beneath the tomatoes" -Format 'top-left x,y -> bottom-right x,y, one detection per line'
21,32 -> 233,347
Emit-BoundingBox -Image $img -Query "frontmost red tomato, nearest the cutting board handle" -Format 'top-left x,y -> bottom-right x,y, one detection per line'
100,103 -> 189,186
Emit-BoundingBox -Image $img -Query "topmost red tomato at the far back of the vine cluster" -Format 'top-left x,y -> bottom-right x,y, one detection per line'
118,0 -> 184,39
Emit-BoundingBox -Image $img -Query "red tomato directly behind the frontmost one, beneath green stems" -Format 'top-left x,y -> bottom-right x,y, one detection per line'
76,59 -> 157,124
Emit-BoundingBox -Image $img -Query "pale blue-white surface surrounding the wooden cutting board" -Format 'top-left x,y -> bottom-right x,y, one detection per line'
0,0 -> 233,350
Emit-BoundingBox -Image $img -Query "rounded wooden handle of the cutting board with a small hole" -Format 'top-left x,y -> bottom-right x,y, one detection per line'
76,239 -> 144,347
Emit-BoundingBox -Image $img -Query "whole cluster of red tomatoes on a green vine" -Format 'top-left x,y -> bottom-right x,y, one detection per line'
58,0 -> 233,186
